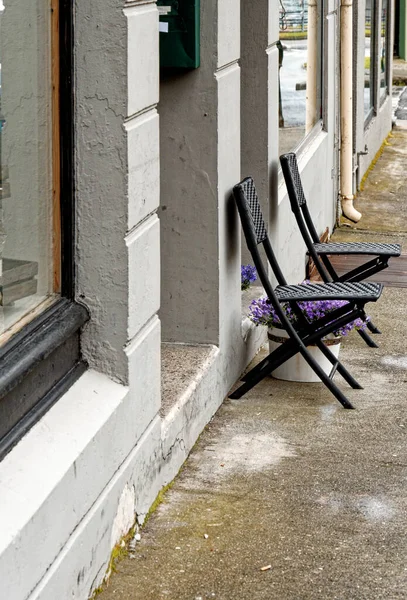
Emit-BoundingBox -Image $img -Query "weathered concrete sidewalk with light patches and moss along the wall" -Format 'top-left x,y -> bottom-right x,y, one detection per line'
98,130 -> 407,600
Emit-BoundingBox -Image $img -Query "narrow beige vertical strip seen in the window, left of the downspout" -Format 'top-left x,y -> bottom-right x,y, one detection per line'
305,0 -> 318,135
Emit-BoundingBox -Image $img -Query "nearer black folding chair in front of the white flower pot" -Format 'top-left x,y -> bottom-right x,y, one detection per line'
230,177 -> 383,408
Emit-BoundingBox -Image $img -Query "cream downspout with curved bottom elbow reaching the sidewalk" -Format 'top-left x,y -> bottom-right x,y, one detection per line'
340,0 -> 362,223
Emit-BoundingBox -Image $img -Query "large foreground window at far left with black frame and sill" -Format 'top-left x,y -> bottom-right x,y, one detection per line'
0,0 -> 87,456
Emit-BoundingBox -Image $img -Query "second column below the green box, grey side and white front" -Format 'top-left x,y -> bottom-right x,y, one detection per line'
159,0 -> 240,344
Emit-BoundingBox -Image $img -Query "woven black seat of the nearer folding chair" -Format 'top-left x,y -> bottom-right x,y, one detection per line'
274,281 -> 383,302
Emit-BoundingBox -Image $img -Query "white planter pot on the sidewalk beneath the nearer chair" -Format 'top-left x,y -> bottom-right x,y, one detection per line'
268,327 -> 341,383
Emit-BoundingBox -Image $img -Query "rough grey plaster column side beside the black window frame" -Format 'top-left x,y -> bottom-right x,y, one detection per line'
75,0 -> 129,382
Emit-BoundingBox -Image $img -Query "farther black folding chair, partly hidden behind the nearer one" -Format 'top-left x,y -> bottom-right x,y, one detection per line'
280,152 -> 401,348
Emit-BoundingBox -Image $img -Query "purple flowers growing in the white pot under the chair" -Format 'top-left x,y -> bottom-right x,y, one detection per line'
249,280 -> 369,336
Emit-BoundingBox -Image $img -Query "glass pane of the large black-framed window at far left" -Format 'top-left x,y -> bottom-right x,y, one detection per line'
0,0 -> 53,333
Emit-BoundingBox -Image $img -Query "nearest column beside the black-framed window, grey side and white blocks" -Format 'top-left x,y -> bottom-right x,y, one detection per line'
75,0 -> 160,438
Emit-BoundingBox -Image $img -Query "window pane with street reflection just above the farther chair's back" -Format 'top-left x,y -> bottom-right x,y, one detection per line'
279,0 -> 323,154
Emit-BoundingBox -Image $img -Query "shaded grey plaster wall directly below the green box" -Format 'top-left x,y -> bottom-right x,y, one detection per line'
159,0 -> 219,343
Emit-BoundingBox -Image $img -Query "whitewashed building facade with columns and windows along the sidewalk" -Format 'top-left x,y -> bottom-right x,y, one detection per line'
0,0 -> 393,600
